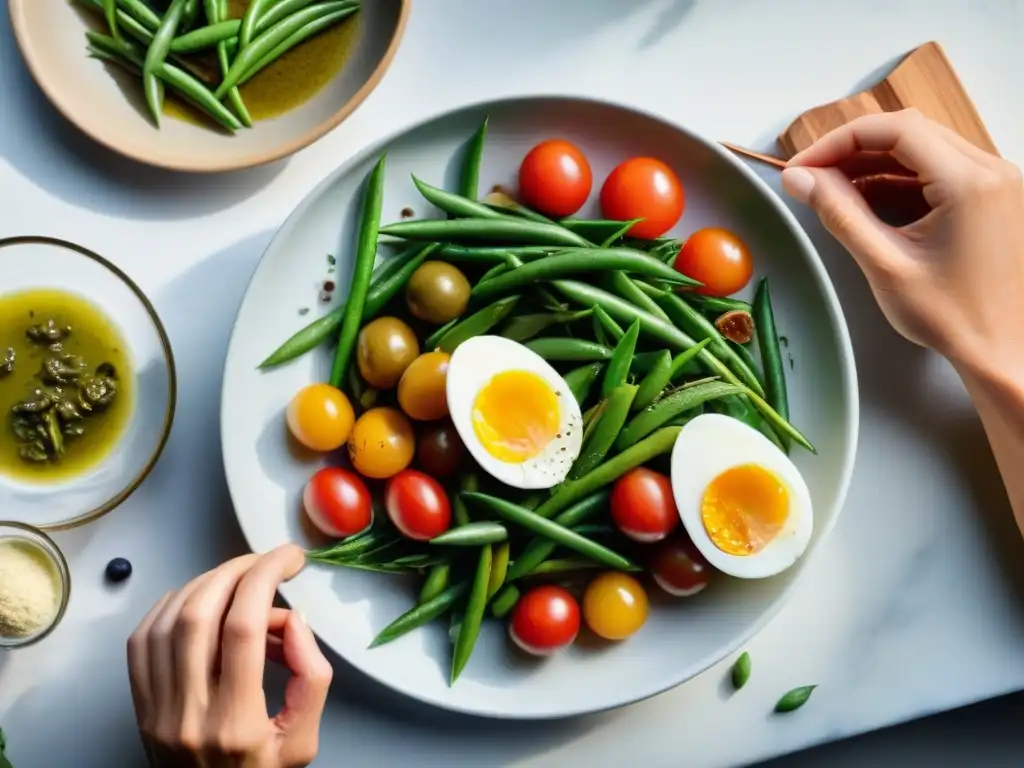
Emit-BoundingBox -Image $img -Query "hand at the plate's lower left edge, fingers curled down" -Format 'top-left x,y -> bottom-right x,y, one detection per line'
128,545 -> 333,768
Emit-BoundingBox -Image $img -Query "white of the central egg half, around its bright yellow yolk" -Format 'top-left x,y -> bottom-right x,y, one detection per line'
445,336 -> 583,489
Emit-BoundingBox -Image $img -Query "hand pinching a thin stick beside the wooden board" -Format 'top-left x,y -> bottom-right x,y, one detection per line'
782,110 -> 1024,373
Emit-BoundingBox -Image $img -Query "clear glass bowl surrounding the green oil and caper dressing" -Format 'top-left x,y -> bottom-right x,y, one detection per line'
0,237 -> 177,530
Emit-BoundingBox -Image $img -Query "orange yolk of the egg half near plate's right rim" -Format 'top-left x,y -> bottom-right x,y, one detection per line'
700,464 -> 790,556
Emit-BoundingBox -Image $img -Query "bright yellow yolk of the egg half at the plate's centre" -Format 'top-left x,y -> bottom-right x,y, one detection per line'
473,371 -> 561,464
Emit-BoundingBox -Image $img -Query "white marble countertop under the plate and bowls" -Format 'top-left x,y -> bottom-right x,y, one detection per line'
0,0 -> 1024,768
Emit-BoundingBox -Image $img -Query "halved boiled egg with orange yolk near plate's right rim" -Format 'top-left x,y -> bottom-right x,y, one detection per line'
672,414 -> 814,579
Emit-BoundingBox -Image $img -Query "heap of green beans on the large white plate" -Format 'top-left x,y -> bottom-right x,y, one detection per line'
280,115 -> 814,683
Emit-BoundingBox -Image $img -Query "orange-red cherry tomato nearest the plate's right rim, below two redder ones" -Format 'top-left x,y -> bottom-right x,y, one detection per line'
675,226 -> 754,296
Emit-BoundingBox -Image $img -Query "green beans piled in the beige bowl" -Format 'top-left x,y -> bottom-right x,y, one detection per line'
77,0 -> 360,131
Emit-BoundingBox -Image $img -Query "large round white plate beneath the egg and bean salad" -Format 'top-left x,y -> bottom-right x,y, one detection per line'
221,98 -> 858,719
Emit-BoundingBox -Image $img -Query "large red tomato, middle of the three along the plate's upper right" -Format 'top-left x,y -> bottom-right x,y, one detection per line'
601,158 -> 686,238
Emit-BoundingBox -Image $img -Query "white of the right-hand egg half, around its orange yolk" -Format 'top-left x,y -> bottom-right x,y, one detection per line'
672,414 -> 814,579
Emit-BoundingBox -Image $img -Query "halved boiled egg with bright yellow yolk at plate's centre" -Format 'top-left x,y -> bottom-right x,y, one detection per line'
445,336 -> 583,488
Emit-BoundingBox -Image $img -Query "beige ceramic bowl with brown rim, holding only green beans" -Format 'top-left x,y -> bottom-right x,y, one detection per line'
8,0 -> 412,172
